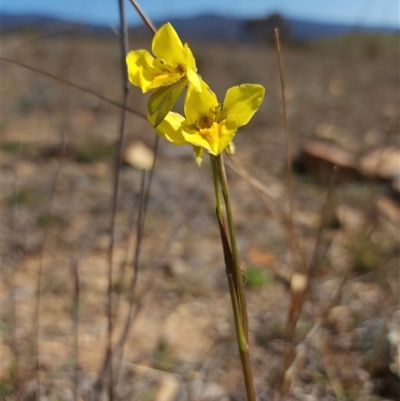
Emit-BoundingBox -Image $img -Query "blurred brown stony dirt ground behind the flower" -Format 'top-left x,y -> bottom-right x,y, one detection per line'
0,26 -> 400,401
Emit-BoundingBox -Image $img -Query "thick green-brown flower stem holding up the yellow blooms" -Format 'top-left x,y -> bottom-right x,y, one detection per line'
210,155 -> 256,401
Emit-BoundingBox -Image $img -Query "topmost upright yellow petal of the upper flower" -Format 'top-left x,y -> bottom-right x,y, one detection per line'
152,22 -> 186,67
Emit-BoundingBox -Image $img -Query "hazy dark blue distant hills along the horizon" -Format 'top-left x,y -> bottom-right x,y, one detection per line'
2,13 -> 399,42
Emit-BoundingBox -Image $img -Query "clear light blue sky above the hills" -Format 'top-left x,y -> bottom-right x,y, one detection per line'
0,0 -> 400,28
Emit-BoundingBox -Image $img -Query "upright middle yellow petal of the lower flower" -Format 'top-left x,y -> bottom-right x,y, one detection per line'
184,80 -> 218,125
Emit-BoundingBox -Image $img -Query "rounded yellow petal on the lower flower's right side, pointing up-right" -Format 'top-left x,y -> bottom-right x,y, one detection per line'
221,84 -> 265,127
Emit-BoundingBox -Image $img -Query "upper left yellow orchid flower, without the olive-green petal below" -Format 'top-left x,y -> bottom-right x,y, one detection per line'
126,23 -> 201,93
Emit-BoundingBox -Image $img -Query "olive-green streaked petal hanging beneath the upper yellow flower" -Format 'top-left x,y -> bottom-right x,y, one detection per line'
147,79 -> 187,128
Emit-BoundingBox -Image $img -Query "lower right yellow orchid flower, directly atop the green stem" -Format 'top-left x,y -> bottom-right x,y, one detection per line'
149,81 -> 265,166
